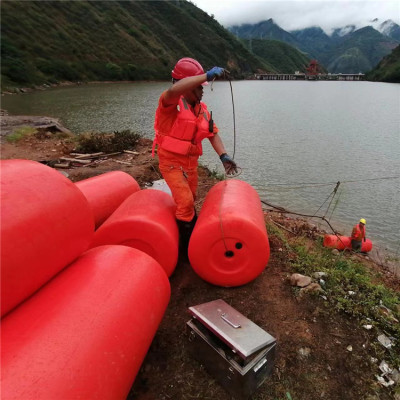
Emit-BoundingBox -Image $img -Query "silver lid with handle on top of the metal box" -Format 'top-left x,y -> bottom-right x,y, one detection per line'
189,299 -> 276,359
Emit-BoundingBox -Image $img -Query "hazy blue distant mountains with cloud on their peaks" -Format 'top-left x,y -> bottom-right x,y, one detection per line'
228,19 -> 400,73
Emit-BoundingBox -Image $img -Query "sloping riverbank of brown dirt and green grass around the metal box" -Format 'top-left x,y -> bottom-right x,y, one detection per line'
1,117 -> 400,400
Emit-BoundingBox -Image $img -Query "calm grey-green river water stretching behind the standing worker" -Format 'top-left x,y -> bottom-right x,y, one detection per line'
1,81 -> 400,256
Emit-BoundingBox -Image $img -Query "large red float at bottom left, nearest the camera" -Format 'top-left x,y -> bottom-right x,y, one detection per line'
1,246 -> 170,400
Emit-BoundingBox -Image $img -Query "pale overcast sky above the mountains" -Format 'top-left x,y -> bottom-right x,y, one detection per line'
192,0 -> 400,34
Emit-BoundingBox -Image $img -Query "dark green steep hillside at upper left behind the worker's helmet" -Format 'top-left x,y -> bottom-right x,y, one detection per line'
1,0 -> 276,87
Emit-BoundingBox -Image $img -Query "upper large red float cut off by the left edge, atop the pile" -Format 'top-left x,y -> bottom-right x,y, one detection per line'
1,160 -> 94,315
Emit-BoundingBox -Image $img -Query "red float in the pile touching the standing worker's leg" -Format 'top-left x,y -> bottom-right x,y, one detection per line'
91,189 -> 179,276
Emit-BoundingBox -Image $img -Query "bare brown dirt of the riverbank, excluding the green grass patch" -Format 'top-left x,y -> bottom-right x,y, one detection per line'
1,126 -> 400,400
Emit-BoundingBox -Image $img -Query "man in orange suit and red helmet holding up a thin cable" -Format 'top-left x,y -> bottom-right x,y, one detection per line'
153,58 -> 237,250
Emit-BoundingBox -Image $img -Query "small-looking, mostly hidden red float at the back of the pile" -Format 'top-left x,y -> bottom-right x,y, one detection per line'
76,171 -> 140,228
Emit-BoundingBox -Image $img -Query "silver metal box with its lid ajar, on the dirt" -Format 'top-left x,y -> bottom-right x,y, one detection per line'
187,299 -> 276,399
